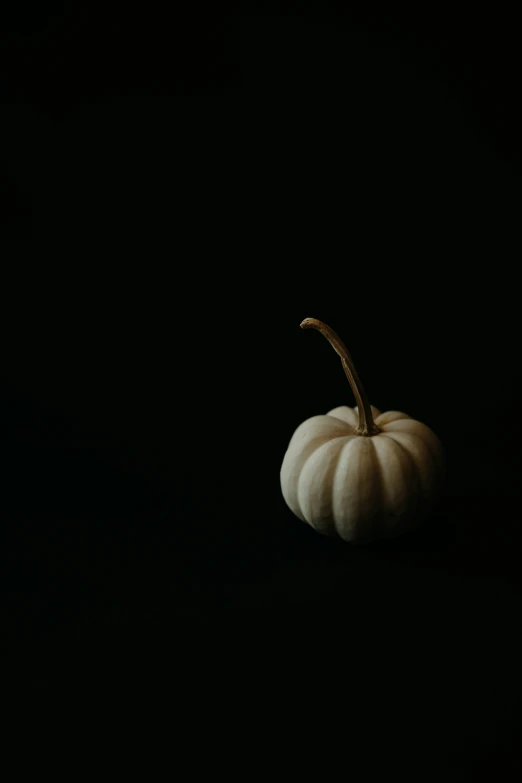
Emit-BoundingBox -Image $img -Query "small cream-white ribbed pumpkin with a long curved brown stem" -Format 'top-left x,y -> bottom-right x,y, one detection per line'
280,318 -> 445,543
